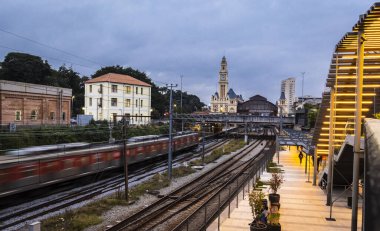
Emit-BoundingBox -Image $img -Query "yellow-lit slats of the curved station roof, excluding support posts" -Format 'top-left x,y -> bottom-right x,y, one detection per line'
313,3 -> 380,155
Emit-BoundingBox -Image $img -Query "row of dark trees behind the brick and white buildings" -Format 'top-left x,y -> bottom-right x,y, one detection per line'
0,52 -> 205,119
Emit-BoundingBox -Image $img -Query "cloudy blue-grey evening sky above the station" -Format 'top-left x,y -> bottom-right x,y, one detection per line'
0,0 -> 374,104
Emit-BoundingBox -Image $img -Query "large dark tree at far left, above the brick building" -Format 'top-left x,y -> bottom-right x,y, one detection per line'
0,52 -> 51,84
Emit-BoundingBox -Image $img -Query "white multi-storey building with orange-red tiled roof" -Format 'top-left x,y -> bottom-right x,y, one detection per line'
84,73 -> 151,125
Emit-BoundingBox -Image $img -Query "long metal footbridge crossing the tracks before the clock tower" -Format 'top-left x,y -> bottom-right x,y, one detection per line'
173,114 -> 294,125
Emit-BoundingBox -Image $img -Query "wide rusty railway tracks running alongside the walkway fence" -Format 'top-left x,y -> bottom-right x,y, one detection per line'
108,137 -> 272,231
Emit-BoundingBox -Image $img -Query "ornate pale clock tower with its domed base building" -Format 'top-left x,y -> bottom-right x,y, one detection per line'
211,56 -> 243,113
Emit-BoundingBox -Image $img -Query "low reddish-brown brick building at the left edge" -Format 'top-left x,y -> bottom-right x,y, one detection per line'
0,80 -> 72,126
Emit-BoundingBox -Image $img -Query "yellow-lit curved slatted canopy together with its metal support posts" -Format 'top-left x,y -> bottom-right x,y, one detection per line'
313,3 -> 380,230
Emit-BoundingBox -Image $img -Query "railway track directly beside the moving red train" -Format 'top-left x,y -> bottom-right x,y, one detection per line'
0,140 -> 228,230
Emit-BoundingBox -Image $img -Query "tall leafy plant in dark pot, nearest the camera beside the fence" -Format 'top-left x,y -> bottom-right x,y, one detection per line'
249,190 -> 267,231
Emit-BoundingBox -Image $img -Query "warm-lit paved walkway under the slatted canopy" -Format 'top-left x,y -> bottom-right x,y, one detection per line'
221,147 -> 361,231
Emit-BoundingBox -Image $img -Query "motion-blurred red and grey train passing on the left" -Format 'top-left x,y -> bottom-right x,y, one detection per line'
0,133 -> 198,197
